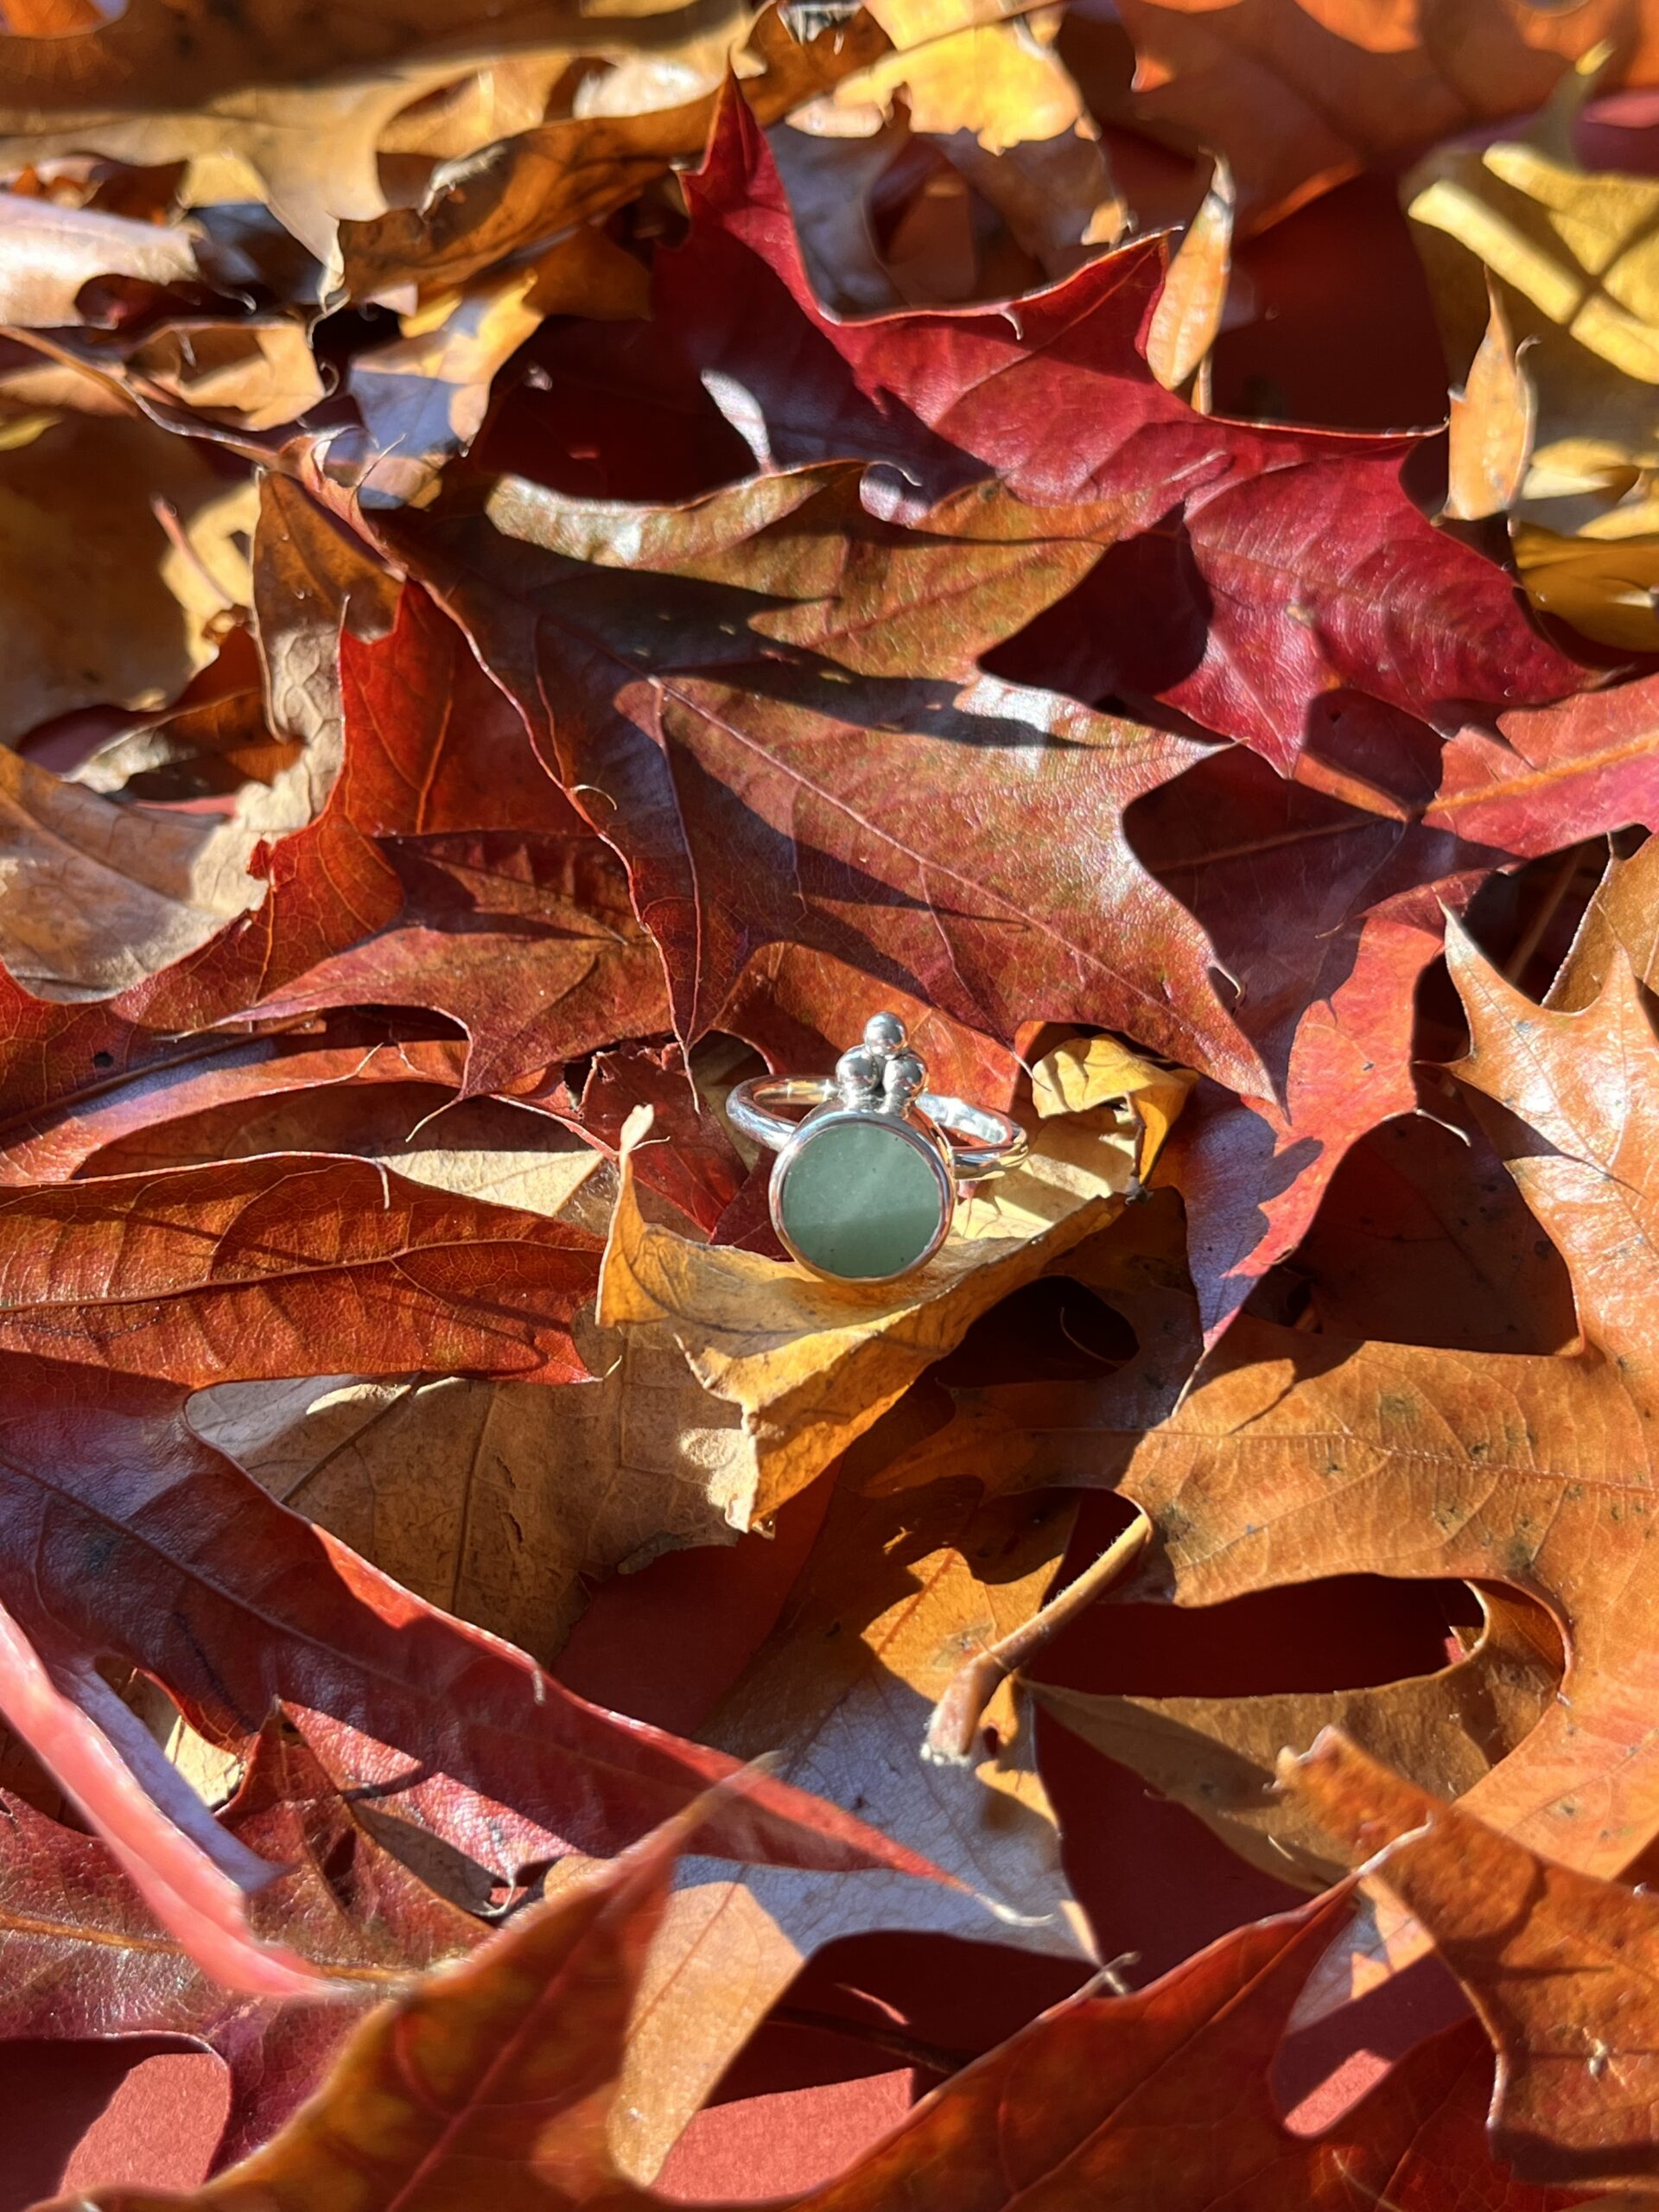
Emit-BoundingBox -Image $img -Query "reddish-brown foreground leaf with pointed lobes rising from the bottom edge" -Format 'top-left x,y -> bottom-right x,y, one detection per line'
53,1787 -> 1573,2212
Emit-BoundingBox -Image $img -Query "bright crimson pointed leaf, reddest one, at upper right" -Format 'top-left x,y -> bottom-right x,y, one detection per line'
540,99 -> 1586,774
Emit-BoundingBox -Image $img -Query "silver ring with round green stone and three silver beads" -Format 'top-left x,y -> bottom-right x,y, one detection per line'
726,1013 -> 1027,1283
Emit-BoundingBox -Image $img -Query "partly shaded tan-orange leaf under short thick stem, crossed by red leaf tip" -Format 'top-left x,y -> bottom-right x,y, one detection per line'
549,1468 -> 1089,2181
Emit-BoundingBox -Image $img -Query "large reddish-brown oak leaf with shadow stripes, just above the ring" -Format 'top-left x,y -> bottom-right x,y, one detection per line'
383,467 -> 1249,1075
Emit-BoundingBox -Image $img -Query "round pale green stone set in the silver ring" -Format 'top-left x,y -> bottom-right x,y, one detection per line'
779,1117 -> 944,1281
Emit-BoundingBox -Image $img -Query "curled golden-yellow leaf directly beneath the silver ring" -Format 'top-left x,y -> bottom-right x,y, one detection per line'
600,1088 -> 1159,1529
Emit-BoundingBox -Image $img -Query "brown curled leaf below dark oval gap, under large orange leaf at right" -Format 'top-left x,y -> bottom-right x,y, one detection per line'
1031,1592 -> 1561,1889
